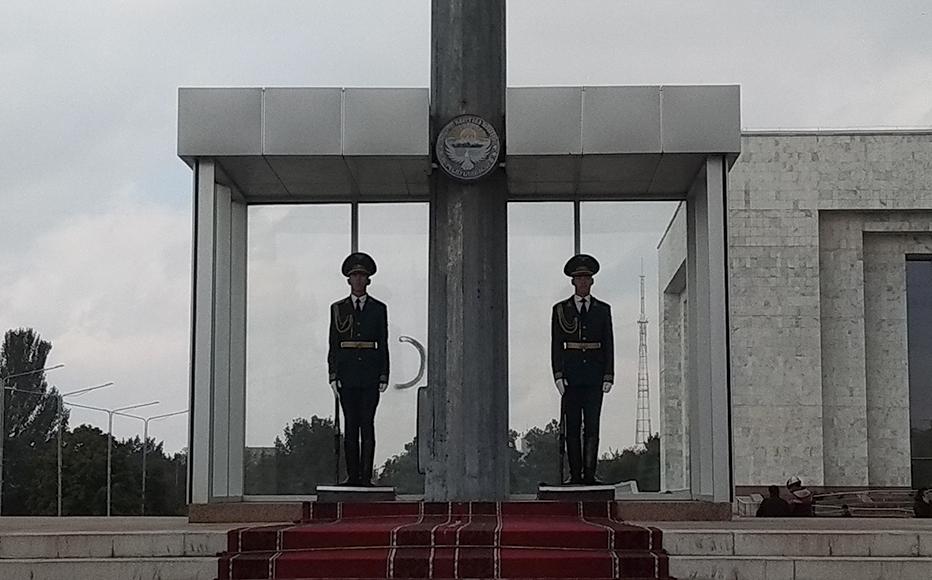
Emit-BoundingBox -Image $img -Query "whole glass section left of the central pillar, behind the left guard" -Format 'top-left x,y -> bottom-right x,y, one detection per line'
244,204 -> 428,495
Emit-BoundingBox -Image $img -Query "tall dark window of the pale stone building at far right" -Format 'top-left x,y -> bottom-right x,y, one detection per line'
906,259 -> 932,488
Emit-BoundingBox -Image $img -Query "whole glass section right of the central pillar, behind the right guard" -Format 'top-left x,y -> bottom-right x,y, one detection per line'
508,202 -> 677,493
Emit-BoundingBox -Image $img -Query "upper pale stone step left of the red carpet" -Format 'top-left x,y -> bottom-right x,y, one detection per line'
0,530 -> 227,560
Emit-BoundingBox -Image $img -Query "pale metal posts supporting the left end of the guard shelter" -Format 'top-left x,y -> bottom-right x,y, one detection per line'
189,160 -> 246,503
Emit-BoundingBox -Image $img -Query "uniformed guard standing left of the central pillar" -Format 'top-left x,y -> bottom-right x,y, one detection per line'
327,252 -> 388,486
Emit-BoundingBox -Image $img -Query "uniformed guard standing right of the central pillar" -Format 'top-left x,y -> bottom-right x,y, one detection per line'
550,254 -> 615,485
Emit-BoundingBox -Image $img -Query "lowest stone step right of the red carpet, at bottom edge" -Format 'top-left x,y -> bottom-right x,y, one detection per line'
669,556 -> 932,580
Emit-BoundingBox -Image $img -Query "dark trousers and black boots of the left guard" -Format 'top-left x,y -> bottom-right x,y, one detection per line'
340,388 -> 380,484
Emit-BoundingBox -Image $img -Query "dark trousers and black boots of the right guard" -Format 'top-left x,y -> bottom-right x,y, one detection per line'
563,385 -> 603,483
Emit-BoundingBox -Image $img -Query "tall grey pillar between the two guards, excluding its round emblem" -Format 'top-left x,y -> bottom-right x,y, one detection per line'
424,0 -> 509,500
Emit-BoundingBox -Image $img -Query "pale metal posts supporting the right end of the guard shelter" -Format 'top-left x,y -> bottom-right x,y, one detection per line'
686,157 -> 733,502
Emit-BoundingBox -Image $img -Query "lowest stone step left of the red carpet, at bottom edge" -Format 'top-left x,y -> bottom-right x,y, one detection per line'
0,557 -> 217,580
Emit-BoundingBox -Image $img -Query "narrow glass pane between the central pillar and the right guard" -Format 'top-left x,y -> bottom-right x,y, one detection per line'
508,203 -> 573,493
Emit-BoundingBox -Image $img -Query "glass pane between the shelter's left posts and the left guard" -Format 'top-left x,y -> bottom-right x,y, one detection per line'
245,204 -> 350,495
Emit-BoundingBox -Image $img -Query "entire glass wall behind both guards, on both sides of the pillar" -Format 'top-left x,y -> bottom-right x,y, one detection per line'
245,202 -> 676,496
